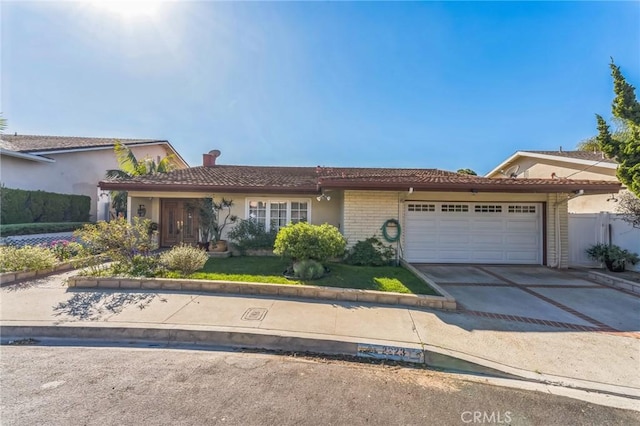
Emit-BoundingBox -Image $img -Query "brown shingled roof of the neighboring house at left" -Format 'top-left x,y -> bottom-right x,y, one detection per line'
0,135 -> 168,153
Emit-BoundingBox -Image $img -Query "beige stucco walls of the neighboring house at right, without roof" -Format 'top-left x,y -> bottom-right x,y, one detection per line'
487,155 -> 626,213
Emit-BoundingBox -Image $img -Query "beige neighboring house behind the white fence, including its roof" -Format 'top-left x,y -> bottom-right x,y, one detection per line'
485,149 -> 626,213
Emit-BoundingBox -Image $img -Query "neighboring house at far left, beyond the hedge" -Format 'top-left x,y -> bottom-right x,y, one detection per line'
0,134 -> 189,220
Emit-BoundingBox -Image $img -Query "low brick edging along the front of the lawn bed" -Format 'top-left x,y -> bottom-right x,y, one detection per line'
67,275 -> 456,310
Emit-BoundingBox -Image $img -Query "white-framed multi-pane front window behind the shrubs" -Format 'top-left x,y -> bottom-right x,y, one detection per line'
247,200 -> 310,230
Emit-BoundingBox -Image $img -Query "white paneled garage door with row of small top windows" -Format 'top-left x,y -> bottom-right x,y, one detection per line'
404,202 -> 542,264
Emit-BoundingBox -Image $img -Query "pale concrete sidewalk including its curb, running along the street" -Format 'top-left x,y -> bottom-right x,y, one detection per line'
0,272 -> 640,398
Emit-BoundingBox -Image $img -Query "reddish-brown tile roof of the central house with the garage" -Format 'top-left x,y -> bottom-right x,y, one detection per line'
100,165 -> 620,193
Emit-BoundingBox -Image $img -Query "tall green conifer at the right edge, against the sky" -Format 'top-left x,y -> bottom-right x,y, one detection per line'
596,60 -> 640,195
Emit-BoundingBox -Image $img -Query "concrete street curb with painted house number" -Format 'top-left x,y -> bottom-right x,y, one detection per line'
0,323 -> 640,400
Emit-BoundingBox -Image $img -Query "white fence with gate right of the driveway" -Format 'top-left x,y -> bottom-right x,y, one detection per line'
569,213 -> 640,271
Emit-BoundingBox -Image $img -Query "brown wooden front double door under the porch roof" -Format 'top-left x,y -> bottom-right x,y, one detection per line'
160,199 -> 198,247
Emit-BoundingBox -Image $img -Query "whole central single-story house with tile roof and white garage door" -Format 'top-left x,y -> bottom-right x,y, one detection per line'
100,151 -> 620,267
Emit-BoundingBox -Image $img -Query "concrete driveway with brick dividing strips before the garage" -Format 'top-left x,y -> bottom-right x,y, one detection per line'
414,264 -> 640,338
